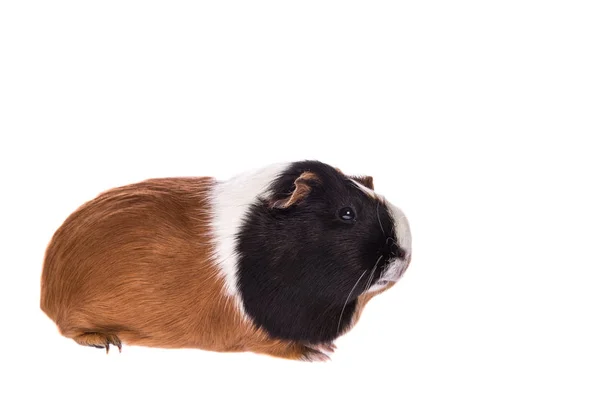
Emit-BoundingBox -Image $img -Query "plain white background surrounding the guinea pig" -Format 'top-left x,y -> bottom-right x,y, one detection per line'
0,0 -> 600,399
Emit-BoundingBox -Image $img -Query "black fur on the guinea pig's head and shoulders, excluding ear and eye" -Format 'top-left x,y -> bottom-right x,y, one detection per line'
237,161 -> 402,343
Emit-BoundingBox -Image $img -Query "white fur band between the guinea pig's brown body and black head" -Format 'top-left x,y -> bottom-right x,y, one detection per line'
211,163 -> 290,318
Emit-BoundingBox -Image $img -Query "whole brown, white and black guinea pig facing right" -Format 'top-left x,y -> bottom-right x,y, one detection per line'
40,160 -> 411,361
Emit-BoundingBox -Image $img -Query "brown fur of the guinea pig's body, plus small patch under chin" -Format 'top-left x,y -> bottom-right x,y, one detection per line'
41,178 -> 384,360
